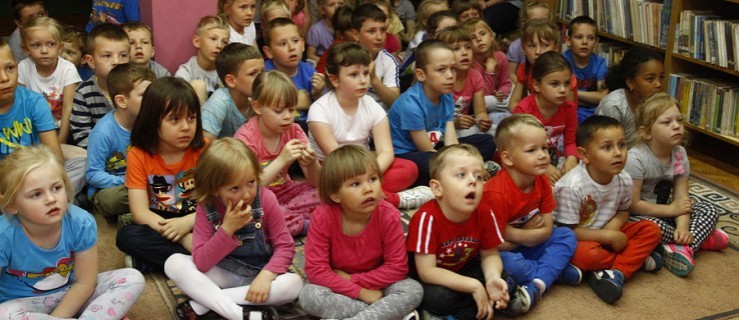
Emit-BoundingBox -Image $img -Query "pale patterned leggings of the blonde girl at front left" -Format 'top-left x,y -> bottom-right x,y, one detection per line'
0,268 -> 144,320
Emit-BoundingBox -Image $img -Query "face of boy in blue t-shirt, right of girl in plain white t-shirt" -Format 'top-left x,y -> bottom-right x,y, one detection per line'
416,49 -> 457,95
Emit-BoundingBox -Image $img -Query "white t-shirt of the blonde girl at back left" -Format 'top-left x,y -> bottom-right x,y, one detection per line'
18,57 -> 82,125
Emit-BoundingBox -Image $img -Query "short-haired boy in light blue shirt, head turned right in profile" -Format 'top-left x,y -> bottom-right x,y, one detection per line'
202,42 -> 264,141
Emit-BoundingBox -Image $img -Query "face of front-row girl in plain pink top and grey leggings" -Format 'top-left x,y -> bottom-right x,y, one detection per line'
331,168 -> 384,215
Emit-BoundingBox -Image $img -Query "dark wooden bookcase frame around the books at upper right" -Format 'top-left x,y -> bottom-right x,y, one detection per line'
545,0 -> 739,149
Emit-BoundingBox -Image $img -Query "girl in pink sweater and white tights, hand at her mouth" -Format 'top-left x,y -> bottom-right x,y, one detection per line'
164,138 -> 303,319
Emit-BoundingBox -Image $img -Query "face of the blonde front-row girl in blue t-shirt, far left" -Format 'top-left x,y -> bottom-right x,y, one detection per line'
6,163 -> 67,227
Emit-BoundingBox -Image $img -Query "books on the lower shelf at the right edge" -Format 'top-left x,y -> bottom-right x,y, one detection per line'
667,73 -> 739,137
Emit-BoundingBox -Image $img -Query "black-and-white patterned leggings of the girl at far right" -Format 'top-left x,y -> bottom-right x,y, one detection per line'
629,202 -> 718,252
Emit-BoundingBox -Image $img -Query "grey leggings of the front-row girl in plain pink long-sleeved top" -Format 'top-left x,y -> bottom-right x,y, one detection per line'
298,279 -> 423,320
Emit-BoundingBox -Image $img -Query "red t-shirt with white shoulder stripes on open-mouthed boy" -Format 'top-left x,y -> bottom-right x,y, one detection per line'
406,200 -> 504,271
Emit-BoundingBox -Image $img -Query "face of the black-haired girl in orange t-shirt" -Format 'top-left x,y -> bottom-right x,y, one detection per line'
158,112 -> 199,152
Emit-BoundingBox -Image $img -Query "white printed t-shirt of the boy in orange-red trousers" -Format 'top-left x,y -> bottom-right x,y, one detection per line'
553,162 -> 632,229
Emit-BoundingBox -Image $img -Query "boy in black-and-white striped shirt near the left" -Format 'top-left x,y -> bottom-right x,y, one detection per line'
69,23 -> 130,148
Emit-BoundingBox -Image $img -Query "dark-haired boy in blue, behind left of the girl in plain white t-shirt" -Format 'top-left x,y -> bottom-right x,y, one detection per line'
263,18 -> 326,132
